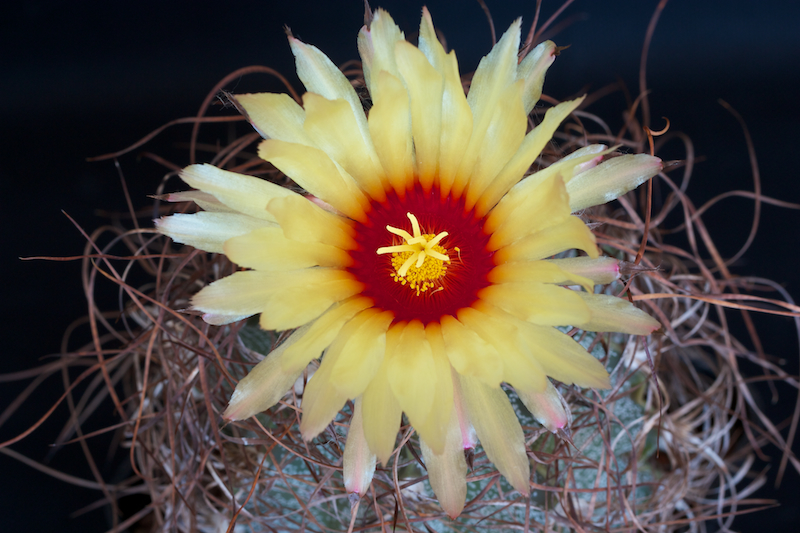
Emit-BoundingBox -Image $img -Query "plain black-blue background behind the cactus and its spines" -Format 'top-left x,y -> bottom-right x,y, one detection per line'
0,0 -> 800,532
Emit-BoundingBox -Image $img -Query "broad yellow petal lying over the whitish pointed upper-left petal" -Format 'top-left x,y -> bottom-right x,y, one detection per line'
303,93 -> 386,202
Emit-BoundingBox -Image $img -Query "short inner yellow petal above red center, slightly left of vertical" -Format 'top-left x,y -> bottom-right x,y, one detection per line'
369,70 -> 414,196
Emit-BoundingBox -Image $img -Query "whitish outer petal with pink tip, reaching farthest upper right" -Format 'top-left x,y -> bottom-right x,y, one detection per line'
567,154 -> 664,212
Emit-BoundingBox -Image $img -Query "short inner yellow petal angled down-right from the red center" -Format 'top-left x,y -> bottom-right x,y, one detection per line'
440,315 -> 503,387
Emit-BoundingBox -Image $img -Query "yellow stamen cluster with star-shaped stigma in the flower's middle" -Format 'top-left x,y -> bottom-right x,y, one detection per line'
377,213 -> 450,296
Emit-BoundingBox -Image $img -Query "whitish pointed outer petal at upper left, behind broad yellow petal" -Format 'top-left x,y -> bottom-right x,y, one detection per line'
289,37 -> 369,148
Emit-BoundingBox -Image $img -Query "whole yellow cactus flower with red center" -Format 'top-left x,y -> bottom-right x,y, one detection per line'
157,9 -> 662,516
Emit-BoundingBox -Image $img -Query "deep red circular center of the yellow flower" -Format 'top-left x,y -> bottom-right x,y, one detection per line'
348,185 -> 495,324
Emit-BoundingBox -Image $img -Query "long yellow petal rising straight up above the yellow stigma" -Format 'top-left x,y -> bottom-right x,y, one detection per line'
395,41 -> 444,191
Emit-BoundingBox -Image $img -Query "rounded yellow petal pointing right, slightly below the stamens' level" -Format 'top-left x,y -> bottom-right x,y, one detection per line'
478,281 -> 592,326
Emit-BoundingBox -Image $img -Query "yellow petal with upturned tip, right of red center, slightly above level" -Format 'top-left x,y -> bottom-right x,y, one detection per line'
495,216 -> 599,264
